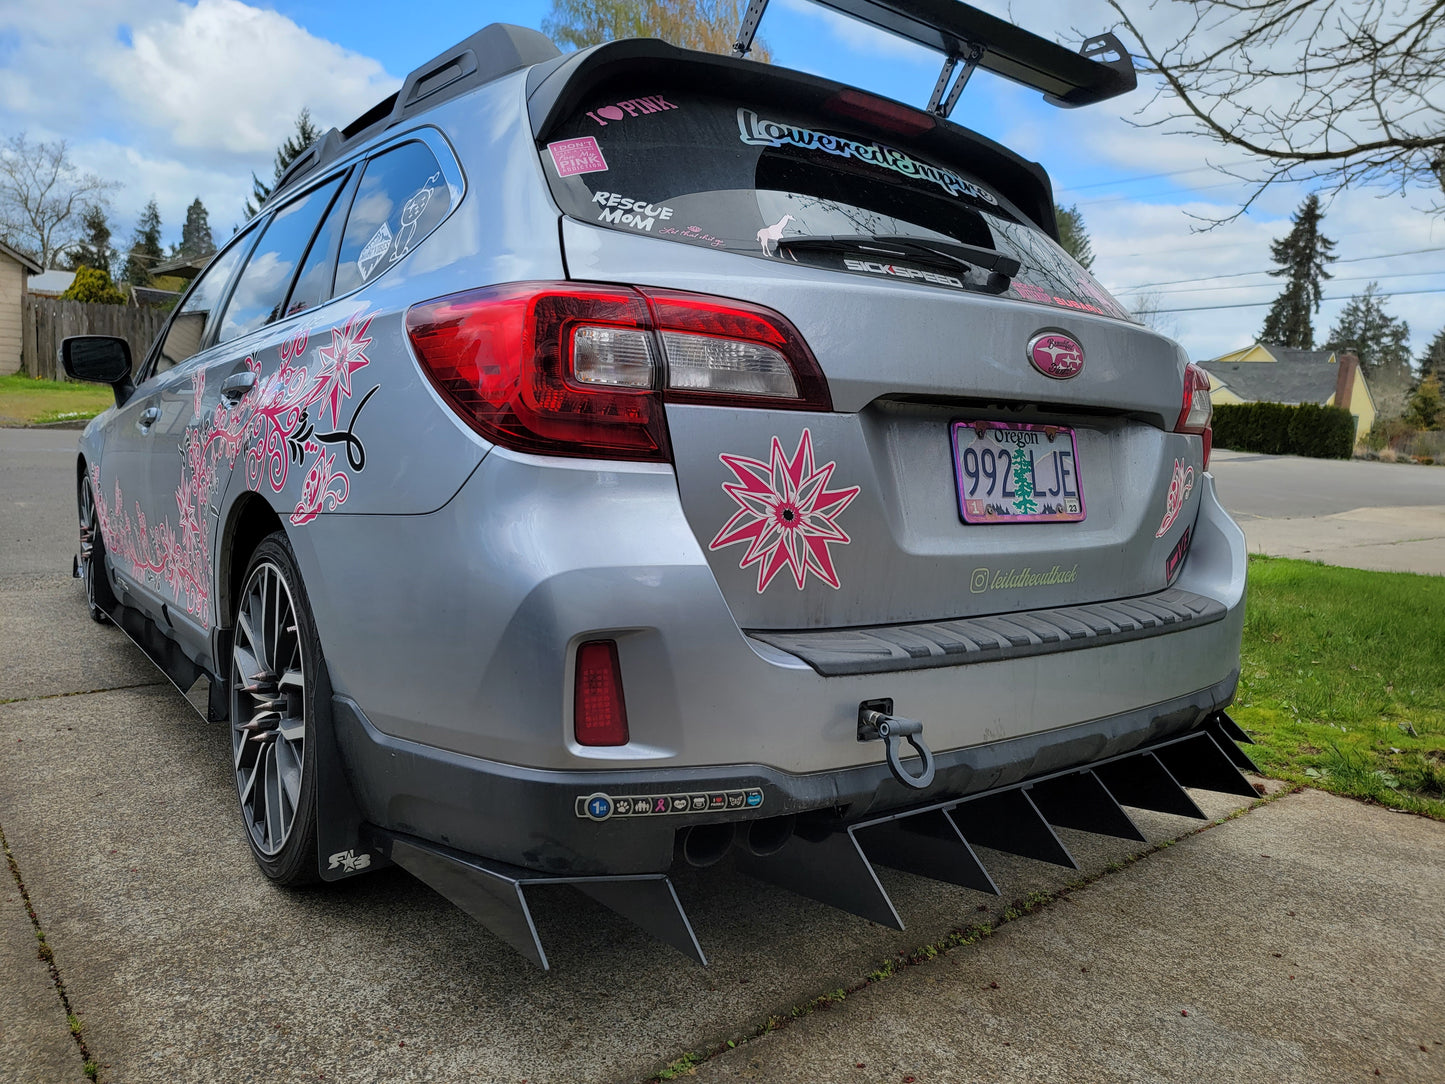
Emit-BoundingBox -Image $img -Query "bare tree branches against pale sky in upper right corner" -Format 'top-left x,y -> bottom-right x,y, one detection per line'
1108,0 -> 1445,224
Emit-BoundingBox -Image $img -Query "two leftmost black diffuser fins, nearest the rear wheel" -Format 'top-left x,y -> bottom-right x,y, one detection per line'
373,830 -> 708,970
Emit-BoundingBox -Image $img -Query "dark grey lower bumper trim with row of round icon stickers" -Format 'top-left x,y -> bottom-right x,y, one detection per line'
332,671 -> 1238,874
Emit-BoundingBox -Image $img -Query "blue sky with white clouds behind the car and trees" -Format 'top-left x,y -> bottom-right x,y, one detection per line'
0,0 -> 1445,358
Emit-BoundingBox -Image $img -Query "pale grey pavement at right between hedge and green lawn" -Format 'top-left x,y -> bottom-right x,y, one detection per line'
1209,451 -> 1445,575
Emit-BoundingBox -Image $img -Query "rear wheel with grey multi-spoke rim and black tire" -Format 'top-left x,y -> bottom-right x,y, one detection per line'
230,530 -> 322,885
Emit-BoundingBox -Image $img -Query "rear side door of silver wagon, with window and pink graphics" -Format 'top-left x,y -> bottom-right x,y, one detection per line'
147,176 -> 342,658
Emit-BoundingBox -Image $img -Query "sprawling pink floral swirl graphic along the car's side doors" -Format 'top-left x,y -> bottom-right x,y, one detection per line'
91,312 -> 376,623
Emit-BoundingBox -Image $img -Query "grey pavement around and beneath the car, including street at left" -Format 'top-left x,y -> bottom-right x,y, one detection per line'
0,431 -> 1445,1084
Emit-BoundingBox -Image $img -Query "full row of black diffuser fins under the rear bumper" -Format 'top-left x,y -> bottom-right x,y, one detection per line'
371,722 -> 1256,968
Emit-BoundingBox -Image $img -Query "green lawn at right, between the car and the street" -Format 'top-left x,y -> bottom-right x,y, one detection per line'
1230,556 -> 1445,820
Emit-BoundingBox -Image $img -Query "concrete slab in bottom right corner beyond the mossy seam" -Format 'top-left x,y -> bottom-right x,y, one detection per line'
695,791 -> 1445,1084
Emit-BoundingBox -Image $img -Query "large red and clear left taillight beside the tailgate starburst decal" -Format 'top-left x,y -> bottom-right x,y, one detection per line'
406,282 -> 832,463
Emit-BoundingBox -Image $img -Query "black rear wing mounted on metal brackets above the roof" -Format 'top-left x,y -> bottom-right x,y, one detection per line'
733,0 -> 1137,117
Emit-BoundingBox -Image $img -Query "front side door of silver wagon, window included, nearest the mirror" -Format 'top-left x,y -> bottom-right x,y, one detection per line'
105,228 -> 259,632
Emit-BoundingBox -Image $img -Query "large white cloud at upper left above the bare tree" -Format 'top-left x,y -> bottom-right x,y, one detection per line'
0,0 -> 399,252
